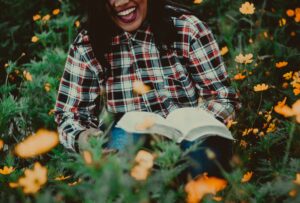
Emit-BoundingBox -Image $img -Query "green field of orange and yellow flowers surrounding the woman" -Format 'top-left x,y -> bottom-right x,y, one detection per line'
0,0 -> 300,203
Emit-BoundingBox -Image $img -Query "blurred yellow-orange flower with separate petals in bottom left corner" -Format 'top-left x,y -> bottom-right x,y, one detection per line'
18,162 -> 47,194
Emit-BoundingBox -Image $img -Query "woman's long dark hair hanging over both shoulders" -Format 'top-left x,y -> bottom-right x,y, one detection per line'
86,0 -> 192,77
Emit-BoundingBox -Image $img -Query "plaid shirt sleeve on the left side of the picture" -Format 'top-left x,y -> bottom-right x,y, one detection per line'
55,42 -> 101,152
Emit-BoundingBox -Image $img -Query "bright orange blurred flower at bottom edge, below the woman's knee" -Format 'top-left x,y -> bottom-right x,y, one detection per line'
185,173 -> 227,203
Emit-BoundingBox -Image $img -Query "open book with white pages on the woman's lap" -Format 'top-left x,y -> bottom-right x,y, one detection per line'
116,107 -> 234,143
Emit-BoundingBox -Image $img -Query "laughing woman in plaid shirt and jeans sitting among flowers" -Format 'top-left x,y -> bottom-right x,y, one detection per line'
55,0 -> 239,178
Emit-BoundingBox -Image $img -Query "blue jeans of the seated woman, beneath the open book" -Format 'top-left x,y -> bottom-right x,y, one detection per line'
106,123 -> 232,177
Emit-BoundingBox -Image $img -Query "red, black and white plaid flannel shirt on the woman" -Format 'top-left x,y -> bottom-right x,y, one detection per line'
55,15 -> 240,151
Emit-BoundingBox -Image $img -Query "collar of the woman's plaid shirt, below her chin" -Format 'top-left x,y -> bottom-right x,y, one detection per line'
112,20 -> 153,45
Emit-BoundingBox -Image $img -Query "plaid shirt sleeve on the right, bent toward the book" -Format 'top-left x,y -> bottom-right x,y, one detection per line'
188,16 -> 241,123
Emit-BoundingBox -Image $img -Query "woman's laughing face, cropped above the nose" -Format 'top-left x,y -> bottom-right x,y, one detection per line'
107,0 -> 148,32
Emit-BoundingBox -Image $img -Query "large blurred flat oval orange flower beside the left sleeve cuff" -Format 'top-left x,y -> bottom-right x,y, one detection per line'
15,129 -> 59,158
